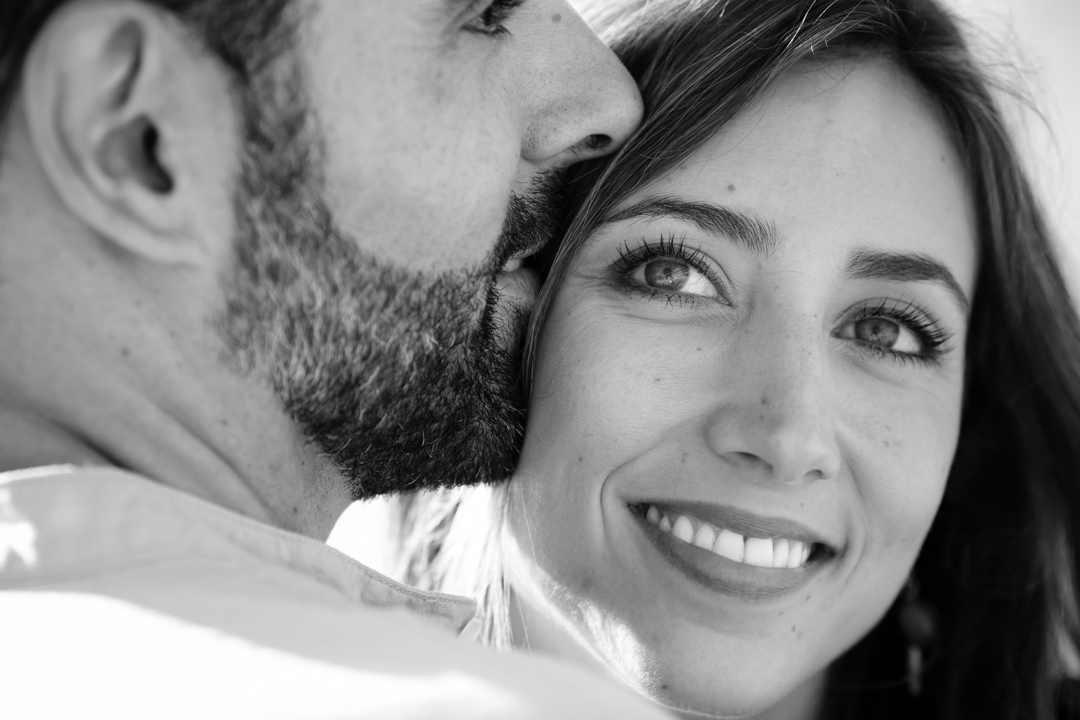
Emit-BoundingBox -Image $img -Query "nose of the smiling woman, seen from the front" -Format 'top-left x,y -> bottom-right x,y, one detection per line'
706,331 -> 840,483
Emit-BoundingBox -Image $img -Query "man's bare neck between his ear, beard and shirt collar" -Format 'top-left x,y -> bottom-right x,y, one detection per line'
0,119 -> 349,540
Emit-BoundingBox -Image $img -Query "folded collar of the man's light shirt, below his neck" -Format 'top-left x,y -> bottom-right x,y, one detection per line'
0,466 -> 476,633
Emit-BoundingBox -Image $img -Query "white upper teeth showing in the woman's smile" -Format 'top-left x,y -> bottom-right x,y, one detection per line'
645,505 -> 810,569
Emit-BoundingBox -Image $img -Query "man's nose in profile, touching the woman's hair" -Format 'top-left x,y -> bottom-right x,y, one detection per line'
521,2 -> 642,167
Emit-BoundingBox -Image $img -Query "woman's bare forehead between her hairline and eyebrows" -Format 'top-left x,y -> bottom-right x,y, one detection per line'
608,58 -> 975,296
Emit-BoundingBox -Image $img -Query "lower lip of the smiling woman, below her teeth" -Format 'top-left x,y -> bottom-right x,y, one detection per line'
627,508 -> 827,601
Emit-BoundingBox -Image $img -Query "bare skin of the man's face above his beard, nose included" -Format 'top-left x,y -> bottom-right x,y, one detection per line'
301,0 -> 639,270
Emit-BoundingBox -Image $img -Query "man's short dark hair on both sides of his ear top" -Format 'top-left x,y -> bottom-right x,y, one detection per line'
0,0 -> 293,155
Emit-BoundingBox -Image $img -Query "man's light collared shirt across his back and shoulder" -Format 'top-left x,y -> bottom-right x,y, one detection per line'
0,467 -> 664,720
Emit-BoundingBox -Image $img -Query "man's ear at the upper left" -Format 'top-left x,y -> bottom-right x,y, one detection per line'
22,0 -> 238,264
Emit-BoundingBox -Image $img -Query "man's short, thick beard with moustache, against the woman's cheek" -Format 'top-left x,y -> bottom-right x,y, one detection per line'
218,77 -> 562,499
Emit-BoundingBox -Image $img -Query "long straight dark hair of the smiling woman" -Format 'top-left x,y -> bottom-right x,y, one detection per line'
401,0 -> 1080,720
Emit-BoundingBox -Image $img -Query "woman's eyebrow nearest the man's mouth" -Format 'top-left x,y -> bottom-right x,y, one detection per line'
605,195 -> 780,257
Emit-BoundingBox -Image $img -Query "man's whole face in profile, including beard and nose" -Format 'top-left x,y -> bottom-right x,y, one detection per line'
222,0 -> 640,497
